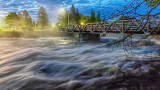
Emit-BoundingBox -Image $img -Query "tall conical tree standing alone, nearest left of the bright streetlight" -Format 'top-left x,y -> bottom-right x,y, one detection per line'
37,7 -> 49,28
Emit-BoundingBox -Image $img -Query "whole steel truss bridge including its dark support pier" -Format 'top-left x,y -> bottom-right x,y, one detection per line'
59,20 -> 160,40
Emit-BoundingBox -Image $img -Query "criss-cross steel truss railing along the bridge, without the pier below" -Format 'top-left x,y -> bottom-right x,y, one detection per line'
58,20 -> 160,33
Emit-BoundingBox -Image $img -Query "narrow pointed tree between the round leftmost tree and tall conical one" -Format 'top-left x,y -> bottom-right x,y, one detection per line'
22,10 -> 32,27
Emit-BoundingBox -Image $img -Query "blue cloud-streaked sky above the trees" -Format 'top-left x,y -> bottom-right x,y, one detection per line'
0,0 -> 159,24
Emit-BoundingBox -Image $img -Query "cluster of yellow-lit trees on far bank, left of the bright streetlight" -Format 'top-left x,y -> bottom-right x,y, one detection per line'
4,7 -> 50,29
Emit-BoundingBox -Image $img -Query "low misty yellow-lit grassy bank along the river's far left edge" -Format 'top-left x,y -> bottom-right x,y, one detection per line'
0,31 -> 74,38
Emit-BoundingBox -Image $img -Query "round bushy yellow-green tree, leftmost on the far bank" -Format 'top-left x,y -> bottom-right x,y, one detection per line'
4,12 -> 22,27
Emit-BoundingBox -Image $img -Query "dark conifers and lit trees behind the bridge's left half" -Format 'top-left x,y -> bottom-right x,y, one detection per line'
57,4 -> 101,26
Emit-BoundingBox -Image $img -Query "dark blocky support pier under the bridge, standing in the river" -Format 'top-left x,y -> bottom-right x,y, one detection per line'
79,33 -> 101,41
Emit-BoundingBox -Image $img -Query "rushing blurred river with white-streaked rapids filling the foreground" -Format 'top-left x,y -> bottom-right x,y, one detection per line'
0,37 -> 160,90
